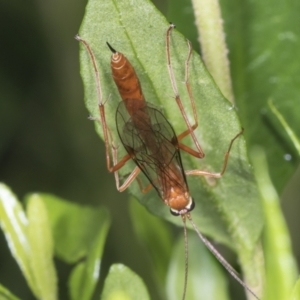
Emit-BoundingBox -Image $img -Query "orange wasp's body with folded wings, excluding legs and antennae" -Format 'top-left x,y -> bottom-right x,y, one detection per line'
109,41 -> 193,216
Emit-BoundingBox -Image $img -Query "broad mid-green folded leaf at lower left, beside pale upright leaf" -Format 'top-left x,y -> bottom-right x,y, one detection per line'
33,194 -> 110,300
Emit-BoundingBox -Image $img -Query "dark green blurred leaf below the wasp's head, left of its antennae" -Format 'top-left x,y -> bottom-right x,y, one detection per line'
130,197 -> 173,288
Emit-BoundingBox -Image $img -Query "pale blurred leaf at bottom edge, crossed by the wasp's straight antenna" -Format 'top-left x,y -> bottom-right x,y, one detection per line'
167,232 -> 229,300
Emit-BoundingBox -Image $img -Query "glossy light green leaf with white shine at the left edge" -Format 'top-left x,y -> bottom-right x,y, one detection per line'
0,183 -> 39,295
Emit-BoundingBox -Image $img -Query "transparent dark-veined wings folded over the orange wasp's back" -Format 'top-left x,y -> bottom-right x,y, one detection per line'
116,101 -> 186,198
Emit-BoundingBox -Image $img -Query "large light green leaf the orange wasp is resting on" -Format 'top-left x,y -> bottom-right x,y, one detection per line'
80,0 -> 263,290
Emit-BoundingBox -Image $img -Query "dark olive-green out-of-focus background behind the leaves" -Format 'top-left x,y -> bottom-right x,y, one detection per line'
0,0 -> 300,299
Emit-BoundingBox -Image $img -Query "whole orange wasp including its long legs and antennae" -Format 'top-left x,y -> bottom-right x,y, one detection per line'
76,24 -> 258,299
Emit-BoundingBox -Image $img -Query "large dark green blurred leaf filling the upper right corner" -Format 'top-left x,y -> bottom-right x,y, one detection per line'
220,0 -> 300,191
